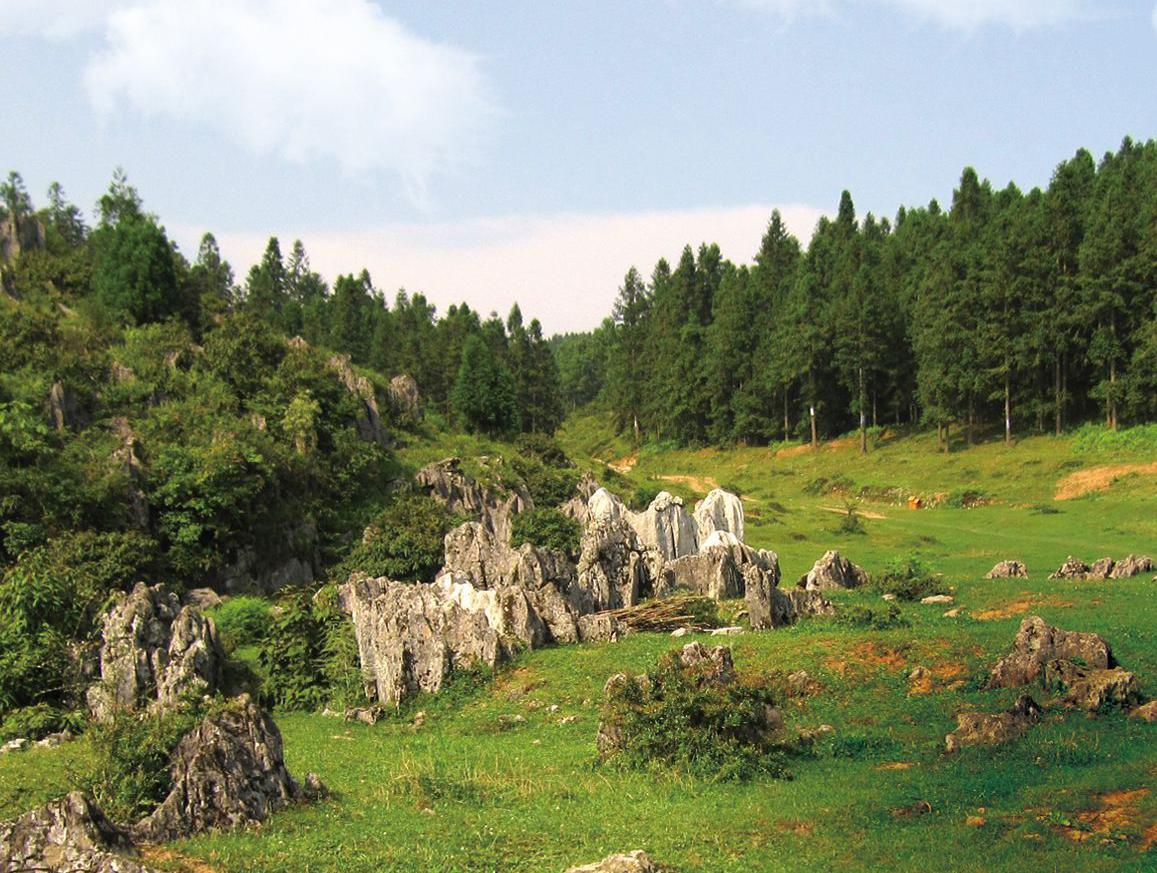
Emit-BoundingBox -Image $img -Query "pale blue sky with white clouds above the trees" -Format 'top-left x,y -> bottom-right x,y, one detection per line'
0,0 -> 1157,333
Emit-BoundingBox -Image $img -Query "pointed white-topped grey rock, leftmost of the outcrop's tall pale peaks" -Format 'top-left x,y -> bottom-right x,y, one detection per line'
577,511 -> 651,611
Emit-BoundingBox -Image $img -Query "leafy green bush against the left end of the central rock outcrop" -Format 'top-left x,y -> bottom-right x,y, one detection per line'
258,585 -> 364,710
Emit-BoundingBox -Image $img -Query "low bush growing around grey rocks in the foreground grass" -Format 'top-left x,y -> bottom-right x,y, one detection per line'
602,650 -> 794,780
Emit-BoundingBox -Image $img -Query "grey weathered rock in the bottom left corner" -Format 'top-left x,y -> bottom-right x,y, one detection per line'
0,792 -> 157,873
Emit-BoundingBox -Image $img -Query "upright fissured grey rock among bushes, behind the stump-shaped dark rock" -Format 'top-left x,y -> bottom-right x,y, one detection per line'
88,584 -> 224,719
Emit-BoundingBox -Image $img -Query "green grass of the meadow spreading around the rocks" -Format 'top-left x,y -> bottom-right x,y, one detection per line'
0,419 -> 1157,873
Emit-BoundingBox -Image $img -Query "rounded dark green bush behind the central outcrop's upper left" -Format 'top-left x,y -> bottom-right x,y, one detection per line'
340,491 -> 450,582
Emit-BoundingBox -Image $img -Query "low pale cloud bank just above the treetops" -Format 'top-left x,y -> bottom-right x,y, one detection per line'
170,205 -> 825,333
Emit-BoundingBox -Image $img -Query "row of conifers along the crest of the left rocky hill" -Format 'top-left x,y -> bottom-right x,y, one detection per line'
0,170 -> 563,436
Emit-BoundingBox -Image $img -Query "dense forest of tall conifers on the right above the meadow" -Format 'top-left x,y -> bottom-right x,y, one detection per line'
553,139 -> 1157,451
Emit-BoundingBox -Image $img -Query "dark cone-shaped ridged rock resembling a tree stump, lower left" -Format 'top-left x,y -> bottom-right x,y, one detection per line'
132,695 -> 302,843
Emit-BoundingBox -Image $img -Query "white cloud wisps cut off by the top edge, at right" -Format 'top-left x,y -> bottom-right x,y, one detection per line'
730,0 -> 1091,31
